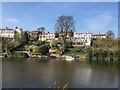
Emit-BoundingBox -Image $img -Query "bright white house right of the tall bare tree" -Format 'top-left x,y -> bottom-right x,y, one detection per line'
74,32 -> 92,46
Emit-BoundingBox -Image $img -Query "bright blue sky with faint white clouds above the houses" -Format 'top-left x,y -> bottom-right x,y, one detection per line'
2,2 -> 118,36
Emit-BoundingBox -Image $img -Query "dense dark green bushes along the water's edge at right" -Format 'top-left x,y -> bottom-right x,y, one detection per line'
87,49 -> 120,61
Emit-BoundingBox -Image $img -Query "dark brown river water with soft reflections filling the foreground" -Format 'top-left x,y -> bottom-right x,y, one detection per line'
2,58 -> 118,88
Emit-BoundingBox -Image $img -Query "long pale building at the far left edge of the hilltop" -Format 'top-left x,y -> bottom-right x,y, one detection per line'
0,27 -> 15,39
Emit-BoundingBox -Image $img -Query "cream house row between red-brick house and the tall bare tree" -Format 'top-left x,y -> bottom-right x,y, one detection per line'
39,33 -> 58,41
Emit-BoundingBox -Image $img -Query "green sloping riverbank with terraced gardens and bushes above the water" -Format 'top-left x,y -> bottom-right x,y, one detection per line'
1,39 -> 120,61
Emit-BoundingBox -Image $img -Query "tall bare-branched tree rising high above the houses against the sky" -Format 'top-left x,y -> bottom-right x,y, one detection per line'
55,15 -> 75,52
